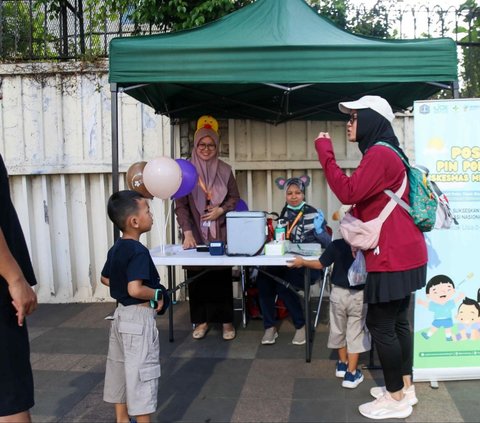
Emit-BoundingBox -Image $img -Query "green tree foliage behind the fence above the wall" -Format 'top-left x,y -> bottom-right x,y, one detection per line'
0,0 -> 480,98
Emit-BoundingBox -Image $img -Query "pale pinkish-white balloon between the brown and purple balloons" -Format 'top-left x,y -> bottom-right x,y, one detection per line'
143,156 -> 182,200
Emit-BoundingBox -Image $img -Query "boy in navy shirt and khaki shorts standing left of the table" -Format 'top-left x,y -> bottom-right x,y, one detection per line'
101,190 -> 169,423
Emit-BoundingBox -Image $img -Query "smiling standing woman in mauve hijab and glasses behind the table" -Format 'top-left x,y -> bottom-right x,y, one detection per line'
175,117 -> 240,340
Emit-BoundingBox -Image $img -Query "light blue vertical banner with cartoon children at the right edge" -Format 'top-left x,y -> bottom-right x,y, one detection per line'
413,99 -> 480,381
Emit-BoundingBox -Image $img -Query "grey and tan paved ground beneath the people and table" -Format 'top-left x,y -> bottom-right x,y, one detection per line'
28,302 -> 480,422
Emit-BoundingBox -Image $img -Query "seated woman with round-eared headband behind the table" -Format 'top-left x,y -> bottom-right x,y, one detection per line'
257,175 -> 331,345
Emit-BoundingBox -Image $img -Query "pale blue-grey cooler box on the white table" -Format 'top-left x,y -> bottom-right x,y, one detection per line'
226,211 -> 267,256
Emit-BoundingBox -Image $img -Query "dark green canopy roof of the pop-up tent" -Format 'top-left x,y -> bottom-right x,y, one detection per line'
110,0 -> 457,122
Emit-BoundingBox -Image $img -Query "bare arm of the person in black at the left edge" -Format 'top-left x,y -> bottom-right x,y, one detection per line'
0,228 -> 37,326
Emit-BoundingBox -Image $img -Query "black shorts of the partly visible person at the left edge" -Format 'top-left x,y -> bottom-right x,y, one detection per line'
0,290 -> 34,416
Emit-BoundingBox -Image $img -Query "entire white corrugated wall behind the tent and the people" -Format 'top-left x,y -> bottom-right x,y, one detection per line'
0,63 -> 413,303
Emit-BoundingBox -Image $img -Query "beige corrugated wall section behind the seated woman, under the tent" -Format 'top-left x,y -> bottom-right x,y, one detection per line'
228,115 -> 413,242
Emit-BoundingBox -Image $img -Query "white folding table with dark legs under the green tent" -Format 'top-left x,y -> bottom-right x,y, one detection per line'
150,245 -> 318,363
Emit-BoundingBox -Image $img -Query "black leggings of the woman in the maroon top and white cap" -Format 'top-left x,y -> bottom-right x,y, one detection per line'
366,296 -> 413,392
